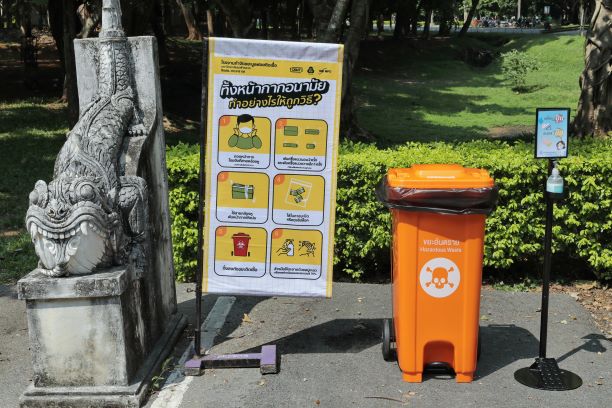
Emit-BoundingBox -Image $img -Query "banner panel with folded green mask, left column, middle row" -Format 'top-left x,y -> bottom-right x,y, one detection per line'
217,171 -> 270,224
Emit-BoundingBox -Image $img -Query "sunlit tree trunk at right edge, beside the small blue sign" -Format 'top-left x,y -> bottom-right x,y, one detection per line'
574,0 -> 612,137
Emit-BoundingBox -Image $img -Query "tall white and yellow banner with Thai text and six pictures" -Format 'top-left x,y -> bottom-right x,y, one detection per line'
202,38 -> 343,297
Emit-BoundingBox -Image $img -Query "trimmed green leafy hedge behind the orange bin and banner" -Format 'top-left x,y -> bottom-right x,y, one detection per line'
168,139 -> 612,280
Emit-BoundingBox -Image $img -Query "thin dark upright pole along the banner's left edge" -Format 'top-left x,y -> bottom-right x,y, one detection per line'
193,38 -> 208,357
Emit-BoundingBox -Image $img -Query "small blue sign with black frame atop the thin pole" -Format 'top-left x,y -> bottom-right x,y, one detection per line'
535,108 -> 570,159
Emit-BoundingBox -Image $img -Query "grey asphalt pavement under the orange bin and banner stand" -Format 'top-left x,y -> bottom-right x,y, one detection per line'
0,283 -> 612,408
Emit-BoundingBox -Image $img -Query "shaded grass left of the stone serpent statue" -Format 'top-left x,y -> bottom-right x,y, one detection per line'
0,99 -> 68,283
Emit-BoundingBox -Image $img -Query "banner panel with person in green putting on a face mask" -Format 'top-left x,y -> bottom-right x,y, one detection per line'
218,114 -> 272,168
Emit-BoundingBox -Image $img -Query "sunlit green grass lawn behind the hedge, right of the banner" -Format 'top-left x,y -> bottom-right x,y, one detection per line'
355,35 -> 584,146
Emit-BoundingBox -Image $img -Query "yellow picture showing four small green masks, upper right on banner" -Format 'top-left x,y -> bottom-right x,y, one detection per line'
275,119 -> 327,156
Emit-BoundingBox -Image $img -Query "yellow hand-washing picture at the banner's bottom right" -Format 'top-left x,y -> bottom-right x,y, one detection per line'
271,228 -> 323,271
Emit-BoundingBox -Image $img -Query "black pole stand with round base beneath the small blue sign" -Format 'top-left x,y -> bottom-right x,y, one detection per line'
514,160 -> 582,391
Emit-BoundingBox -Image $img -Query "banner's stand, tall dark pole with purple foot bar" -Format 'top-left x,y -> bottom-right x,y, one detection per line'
184,38 -> 278,376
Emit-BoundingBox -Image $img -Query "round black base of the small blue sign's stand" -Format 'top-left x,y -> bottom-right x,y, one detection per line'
514,357 -> 582,391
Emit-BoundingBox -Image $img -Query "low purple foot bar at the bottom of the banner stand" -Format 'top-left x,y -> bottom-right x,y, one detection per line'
185,345 -> 278,376
